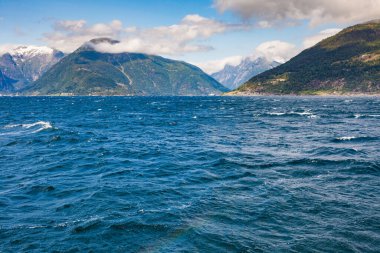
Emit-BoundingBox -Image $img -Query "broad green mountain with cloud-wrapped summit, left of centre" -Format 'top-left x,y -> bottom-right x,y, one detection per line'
24,38 -> 228,96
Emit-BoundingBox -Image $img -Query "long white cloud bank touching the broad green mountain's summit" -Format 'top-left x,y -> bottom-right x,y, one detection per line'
43,15 -> 247,55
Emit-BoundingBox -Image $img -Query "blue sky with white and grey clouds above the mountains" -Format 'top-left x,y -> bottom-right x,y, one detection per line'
0,0 -> 380,73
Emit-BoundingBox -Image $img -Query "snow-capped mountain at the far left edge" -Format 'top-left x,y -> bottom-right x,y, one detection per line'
0,46 -> 64,91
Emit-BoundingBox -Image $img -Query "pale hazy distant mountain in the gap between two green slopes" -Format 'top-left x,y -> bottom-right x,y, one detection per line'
211,57 -> 281,90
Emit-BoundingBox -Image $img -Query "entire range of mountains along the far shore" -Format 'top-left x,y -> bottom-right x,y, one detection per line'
0,21 -> 380,96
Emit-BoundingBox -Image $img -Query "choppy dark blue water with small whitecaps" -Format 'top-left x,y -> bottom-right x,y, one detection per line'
0,97 -> 380,252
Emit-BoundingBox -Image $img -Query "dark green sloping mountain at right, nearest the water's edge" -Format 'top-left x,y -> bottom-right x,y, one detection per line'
228,21 -> 380,95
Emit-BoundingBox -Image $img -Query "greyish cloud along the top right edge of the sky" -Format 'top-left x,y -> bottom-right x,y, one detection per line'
214,0 -> 380,27
